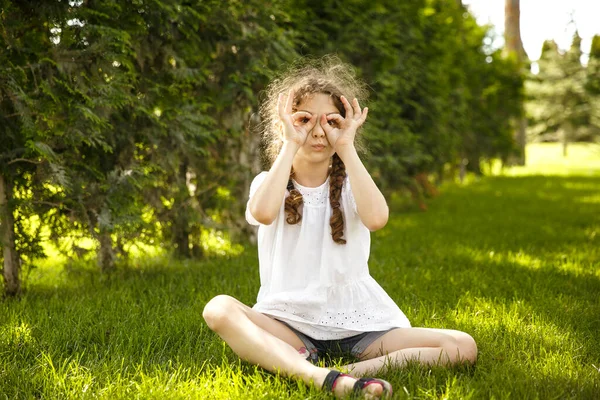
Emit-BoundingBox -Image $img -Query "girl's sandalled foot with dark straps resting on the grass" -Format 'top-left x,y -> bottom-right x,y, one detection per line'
323,370 -> 392,400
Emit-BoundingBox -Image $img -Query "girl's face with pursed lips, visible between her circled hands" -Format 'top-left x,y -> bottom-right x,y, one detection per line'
294,93 -> 340,162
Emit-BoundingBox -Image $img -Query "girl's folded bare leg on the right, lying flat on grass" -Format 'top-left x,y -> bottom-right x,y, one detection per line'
346,328 -> 477,375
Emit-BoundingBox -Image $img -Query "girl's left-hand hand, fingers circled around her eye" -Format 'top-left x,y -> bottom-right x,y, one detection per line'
277,90 -> 317,147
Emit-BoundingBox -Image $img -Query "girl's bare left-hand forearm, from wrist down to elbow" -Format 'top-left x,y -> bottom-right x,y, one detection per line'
248,142 -> 299,225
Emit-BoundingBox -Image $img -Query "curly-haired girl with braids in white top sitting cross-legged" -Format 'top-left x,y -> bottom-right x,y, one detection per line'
203,58 -> 477,399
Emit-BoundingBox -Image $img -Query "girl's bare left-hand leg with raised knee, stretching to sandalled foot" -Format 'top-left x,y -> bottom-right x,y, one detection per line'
202,295 -> 383,399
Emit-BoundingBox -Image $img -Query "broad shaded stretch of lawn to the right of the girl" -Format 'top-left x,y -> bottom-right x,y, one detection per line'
382,176 -> 600,308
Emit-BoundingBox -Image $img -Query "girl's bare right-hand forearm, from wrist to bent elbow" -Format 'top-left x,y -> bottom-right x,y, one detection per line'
337,146 -> 389,231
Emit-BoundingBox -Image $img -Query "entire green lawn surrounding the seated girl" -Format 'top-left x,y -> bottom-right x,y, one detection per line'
0,145 -> 600,399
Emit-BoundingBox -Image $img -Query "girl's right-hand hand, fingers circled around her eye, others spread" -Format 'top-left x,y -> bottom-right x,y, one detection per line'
319,96 -> 369,155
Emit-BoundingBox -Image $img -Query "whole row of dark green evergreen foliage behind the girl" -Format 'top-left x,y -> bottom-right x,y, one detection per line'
0,0 -> 521,290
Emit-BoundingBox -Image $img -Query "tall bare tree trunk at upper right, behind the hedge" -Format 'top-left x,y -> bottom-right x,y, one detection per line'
504,0 -> 527,165
